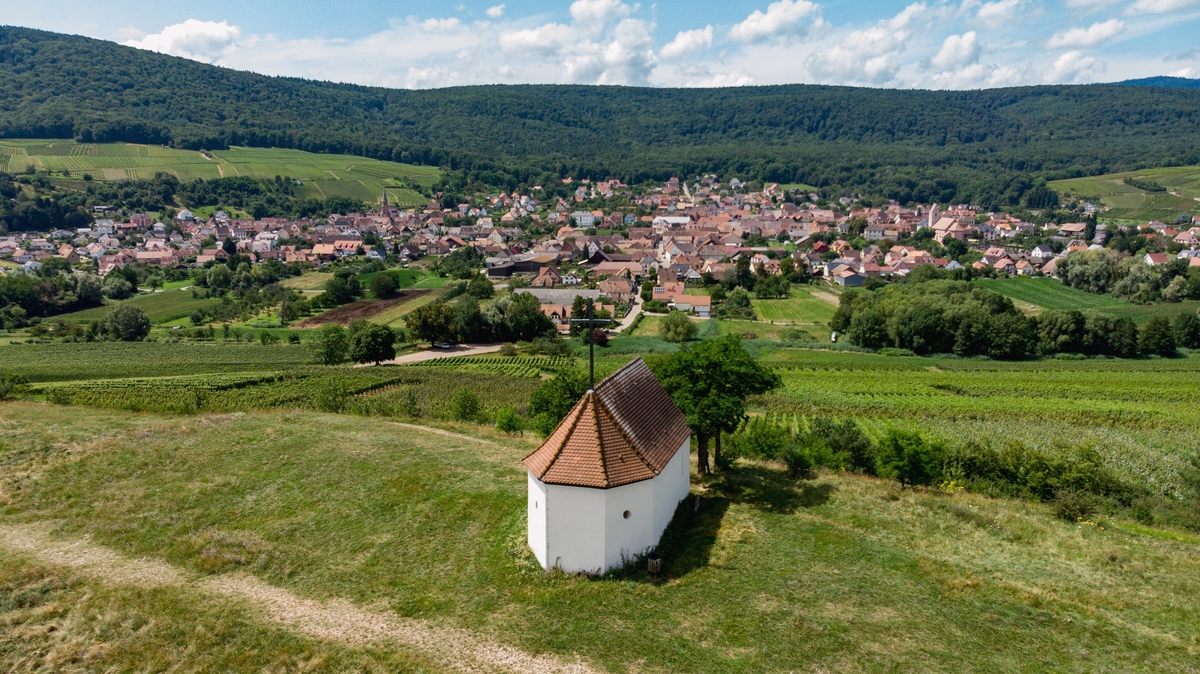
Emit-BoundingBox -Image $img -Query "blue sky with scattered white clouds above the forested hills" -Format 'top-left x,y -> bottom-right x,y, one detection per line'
0,0 -> 1200,89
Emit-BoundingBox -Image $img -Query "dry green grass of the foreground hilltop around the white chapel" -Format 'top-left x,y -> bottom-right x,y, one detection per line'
0,403 -> 1200,673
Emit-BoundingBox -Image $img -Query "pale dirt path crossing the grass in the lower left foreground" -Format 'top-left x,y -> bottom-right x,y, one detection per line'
0,524 -> 598,674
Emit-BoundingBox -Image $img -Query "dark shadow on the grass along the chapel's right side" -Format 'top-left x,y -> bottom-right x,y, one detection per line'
606,465 -> 834,583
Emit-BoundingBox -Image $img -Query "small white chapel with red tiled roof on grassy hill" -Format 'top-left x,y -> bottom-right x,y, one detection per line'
524,359 -> 691,573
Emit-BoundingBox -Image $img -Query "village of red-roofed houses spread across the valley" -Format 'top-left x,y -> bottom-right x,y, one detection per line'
0,175 -> 1200,331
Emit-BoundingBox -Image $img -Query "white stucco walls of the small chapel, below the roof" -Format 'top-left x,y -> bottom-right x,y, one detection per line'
528,440 -> 691,573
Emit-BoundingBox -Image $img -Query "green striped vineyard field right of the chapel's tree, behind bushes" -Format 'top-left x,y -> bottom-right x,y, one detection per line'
756,349 -> 1200,493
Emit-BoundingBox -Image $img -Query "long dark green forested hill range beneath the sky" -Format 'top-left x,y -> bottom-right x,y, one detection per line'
0,28 -> 1200,205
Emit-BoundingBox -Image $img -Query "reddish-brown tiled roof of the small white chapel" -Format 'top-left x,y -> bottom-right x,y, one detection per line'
524,359 -> 691,489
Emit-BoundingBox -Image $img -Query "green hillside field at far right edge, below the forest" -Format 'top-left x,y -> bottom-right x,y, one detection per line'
1050,167 -> 1200,224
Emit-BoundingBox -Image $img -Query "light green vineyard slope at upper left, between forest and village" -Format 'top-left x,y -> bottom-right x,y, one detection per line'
0,140 -> 439,206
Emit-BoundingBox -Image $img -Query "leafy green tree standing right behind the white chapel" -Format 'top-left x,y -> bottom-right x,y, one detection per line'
654,335 -> 781,475
